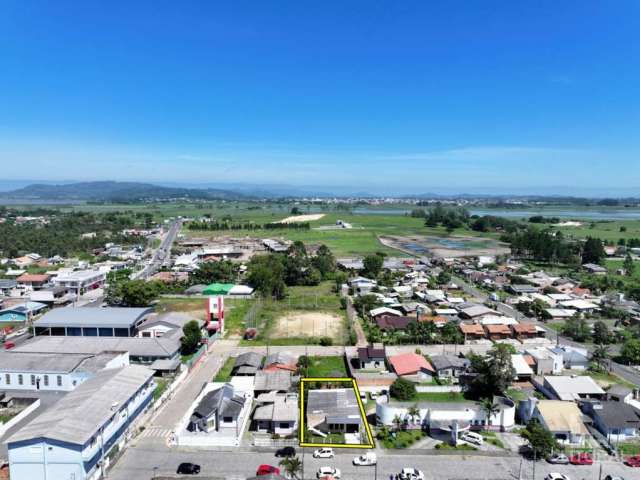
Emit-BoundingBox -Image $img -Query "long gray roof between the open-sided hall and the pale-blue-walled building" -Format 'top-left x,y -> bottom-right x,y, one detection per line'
13,334 -> 180,358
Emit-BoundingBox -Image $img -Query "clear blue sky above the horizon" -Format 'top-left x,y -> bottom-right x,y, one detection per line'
0,0 -> 640,193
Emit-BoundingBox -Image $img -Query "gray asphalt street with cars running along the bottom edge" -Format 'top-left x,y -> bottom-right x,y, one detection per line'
108,445 -> 639,480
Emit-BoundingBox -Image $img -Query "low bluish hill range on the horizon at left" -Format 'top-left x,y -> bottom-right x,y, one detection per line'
1,181 -> 247,202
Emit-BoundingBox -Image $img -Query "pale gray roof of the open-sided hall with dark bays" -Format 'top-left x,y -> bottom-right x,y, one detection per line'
34,307 -> 153,328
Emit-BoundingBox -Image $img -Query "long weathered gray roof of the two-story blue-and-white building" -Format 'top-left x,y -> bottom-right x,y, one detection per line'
7,365 -> 153,447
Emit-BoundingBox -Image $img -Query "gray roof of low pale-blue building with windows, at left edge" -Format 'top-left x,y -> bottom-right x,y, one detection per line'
0,351 -> 116,374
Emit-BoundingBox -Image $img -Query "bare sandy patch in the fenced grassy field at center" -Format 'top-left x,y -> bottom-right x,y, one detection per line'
271,312 -> 343,338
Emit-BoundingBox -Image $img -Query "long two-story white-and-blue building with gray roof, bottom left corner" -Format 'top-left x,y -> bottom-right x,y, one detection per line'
7,365 -> 155,480
